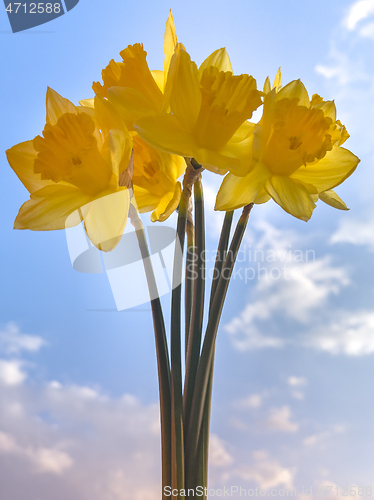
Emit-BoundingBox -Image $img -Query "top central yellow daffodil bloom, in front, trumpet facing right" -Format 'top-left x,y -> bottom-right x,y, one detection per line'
135,44 -> 262,174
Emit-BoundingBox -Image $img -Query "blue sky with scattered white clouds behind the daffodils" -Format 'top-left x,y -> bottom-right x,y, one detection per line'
0,0 -> 374,500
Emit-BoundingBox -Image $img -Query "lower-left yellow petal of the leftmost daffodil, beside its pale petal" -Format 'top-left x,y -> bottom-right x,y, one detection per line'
14,184 -> 92,231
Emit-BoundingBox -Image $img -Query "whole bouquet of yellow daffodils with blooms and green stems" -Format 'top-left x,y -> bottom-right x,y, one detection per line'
7,13 -> 359,500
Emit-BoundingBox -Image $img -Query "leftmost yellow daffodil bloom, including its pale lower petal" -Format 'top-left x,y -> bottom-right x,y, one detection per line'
7,89 -> 132,251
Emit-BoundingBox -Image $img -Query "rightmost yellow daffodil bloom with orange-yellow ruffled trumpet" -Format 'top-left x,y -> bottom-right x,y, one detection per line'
215,72 -> 360,221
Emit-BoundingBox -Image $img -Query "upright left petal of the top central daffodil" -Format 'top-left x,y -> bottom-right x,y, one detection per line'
170,50 -> 202,132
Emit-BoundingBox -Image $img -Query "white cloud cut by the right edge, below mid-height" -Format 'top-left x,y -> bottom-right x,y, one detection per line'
306,311 -> 374,356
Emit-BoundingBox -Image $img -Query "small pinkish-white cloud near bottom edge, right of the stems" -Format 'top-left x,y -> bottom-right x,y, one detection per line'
231,450 -> 295,489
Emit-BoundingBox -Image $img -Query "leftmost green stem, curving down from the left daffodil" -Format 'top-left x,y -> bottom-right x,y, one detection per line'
131,210 -> 171,500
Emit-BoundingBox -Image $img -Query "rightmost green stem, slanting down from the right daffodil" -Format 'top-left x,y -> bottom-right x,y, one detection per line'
186,203 -> 253,474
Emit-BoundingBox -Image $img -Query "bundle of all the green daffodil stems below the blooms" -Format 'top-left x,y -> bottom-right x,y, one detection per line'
130,159 -> 253,500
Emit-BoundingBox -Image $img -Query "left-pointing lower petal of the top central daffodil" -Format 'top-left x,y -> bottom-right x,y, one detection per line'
135,113 -> 197,156
